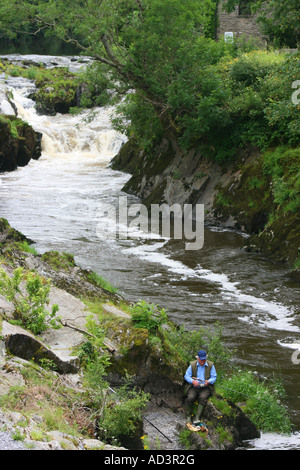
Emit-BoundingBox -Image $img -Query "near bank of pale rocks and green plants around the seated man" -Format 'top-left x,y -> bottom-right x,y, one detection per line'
0,219 -> 291,449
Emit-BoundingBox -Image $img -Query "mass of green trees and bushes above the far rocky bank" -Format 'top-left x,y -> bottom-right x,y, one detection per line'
0,0 -> 300,162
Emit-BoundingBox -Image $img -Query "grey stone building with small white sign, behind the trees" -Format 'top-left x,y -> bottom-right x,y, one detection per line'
216,0 -> 263,41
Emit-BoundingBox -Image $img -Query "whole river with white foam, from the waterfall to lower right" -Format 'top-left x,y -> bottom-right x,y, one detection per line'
0,55 -> 300,449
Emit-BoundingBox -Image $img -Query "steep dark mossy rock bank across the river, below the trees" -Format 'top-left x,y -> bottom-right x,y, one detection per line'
112,138 -> 300,275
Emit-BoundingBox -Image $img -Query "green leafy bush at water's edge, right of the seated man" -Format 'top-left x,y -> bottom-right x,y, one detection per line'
219,371 -> 291,433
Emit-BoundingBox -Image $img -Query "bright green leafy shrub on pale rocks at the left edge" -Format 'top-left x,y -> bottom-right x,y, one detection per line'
0,268 -> 58,334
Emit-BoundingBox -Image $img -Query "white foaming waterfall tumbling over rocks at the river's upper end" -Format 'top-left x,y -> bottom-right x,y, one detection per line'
0,56 -> 126,163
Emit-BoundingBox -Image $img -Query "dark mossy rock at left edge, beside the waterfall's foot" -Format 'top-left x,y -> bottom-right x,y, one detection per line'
0,115 -> 42,172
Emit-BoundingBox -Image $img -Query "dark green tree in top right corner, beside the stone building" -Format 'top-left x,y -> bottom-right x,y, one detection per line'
225,0 -> 300,48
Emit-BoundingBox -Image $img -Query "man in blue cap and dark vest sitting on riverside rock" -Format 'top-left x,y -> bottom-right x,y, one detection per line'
184,350 -> 217,426
